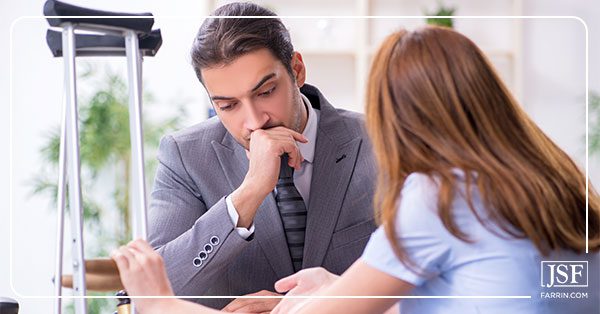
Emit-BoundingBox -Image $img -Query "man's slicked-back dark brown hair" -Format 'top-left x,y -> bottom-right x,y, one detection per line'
191,2 -> 294,82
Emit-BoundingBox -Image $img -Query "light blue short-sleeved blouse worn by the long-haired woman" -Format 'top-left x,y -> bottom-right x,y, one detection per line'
362,171 -> 600,314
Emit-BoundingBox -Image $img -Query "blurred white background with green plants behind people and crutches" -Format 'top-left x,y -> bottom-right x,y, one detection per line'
0,0 -> 600,313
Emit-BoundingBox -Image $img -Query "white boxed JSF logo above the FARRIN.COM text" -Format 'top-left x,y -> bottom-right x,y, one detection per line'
541,261 -> 588,288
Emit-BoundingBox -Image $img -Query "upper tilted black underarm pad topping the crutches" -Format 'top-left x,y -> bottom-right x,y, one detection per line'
44,0 -> 154,33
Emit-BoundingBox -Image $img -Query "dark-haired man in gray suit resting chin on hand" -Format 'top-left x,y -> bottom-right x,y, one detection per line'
149,3 -> 376,312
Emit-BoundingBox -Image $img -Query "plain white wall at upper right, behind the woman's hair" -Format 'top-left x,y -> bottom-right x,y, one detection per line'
523,1 -> 600,186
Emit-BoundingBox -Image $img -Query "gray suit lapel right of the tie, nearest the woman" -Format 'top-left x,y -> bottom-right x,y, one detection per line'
302,96 -> 362,268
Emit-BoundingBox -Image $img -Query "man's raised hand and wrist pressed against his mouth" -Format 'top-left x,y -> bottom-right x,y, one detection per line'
231,126 -> 308,228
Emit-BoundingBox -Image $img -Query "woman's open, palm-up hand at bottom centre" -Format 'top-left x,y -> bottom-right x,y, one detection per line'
271,267 -> 339,314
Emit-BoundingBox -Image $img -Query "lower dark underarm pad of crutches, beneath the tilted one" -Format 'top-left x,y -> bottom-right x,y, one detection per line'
47,29 -> 162,57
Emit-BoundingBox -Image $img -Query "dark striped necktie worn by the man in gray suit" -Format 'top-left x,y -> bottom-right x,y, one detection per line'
275,154 -> 306,272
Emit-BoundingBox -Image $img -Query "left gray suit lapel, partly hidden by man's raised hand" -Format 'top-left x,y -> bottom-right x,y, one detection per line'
211,133 -> 294,278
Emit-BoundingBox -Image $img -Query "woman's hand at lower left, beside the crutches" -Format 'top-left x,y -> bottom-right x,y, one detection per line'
110,239 -> 174,313
